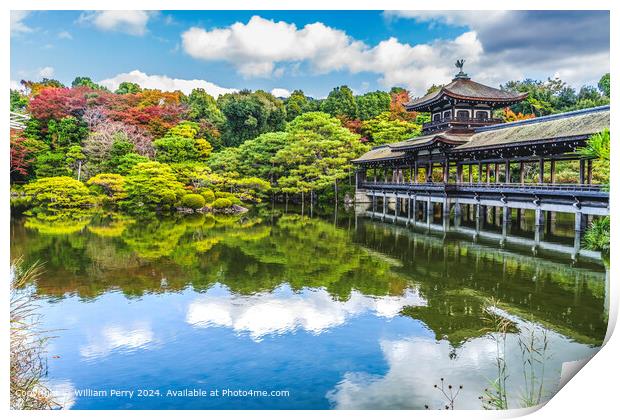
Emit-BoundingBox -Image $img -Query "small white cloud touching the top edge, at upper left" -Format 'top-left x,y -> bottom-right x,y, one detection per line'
78,10 -> 154,36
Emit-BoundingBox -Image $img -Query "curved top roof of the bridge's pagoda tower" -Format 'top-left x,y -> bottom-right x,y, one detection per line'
405,77 -> 527,111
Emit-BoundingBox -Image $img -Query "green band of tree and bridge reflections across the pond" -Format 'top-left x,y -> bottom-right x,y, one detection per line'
12,208 -> 606,346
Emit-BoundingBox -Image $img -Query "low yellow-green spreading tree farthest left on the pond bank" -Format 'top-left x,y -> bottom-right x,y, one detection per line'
24,176 -> 95,209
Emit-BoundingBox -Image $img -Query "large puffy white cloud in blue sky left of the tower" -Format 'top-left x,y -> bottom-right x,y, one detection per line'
182,16 -> 483,91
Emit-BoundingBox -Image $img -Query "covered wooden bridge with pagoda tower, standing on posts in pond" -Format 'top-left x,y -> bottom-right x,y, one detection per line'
353,65 -> 610,253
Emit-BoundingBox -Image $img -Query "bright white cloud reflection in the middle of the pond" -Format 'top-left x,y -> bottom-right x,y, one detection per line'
186,287 -> 426,340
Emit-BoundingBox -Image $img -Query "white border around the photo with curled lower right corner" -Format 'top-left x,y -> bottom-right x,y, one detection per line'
0,0 -> 620,420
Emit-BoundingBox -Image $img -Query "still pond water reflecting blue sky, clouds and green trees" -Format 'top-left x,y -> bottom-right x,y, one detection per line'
11,209 -> 607,409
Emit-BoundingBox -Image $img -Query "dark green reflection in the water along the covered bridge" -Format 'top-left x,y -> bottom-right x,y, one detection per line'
356,223 -> 607,345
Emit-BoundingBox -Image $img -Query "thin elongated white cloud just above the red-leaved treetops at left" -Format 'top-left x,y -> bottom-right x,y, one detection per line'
99,70 -> 237,98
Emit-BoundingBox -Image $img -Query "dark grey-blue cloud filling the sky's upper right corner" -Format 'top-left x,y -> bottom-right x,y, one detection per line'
385,10 -> 609,86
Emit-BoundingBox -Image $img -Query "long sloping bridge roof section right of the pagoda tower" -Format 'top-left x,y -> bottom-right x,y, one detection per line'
453,106 -> 609,152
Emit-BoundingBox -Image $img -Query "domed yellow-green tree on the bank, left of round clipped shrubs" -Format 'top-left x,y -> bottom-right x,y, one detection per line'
123,162 -> 185,212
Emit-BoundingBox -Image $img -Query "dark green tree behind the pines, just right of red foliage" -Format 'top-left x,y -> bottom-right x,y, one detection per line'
217,90 -> 286,146
